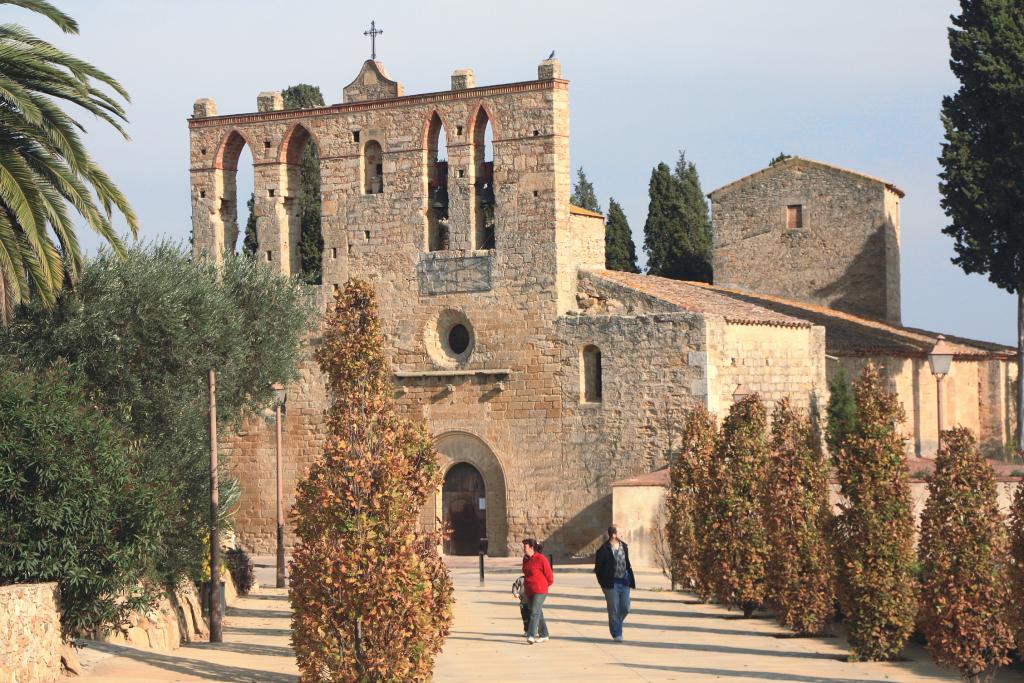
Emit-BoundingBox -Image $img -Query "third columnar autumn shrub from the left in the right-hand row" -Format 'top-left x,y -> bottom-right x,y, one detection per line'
763,398 -> 836,635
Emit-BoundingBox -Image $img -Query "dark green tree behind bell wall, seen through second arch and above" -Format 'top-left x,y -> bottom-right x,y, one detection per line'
282,83 -> 324,285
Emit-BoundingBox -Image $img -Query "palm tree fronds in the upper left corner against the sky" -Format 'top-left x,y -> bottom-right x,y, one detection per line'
0,0 -> 138,326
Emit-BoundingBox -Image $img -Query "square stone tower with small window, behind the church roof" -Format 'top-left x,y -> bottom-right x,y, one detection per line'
709,157 -> 903,324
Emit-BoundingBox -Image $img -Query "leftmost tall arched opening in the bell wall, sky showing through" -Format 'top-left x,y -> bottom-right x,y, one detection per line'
214,130 -> 253,256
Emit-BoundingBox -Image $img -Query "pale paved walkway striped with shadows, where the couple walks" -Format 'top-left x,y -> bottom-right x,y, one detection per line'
83,558 -> 1024,683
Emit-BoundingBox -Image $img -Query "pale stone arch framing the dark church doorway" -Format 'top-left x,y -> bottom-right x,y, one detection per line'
434,431 -> 509,556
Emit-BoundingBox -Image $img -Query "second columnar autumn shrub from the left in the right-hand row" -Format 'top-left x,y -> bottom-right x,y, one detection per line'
702,394 -> 768,616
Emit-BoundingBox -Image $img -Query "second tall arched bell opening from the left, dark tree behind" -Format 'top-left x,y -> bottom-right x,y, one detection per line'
282,125 -> 324,285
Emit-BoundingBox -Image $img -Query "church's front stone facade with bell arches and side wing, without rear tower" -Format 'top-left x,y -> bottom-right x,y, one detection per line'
189,59 -> 824,557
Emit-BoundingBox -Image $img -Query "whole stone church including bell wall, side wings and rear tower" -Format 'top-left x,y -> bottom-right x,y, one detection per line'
188,59 -> 1009,557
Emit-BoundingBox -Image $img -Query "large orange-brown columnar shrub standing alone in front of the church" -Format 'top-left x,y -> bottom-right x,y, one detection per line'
289,281 -> 453,683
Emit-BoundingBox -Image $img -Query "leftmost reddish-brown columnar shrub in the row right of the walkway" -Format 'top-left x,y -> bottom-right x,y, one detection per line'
666,405 -> 717,597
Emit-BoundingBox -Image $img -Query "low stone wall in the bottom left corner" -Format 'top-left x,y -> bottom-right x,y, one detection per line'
0,584 -> 61,683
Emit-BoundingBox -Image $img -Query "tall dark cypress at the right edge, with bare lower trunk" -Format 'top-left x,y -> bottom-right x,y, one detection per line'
939,0 -> 1024,451
